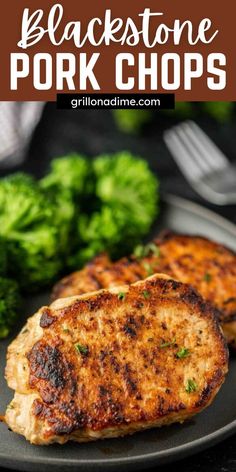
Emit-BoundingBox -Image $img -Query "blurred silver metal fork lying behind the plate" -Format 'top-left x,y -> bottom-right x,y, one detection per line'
164,120 -> 236,205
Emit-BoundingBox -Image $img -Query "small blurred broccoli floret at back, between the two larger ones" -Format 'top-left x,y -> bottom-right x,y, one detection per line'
40,154 -> 91,199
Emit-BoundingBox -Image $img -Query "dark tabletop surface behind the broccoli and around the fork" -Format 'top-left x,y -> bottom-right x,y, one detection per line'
0,103 -> 236,472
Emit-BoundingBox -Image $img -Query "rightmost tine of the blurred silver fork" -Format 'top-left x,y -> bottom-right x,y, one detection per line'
184,120 -> 228,171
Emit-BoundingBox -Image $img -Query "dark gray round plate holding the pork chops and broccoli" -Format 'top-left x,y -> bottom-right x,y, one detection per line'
0,196 -> 236,472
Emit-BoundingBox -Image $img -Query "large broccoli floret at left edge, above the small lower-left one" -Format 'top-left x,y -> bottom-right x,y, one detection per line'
0,173 -> 62,290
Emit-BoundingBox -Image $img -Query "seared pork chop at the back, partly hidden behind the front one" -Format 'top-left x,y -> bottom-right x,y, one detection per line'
53,232 -> 236,347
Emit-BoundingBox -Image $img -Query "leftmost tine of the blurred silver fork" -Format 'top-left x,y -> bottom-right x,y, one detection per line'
163,128 -> 205,182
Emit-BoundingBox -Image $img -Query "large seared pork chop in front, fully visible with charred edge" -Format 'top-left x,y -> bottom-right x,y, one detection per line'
6,275 -> 228,445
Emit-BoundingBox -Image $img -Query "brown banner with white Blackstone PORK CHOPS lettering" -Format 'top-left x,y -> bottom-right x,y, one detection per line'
0,0 -> 236,101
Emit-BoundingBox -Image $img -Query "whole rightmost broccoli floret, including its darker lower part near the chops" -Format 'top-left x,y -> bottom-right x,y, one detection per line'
70,152 -> 158,266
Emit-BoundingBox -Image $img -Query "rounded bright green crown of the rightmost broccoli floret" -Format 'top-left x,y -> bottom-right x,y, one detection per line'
94,152 -> 158,237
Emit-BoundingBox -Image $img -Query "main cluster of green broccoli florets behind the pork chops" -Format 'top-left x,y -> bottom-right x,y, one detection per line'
0,152 -> 158,291
